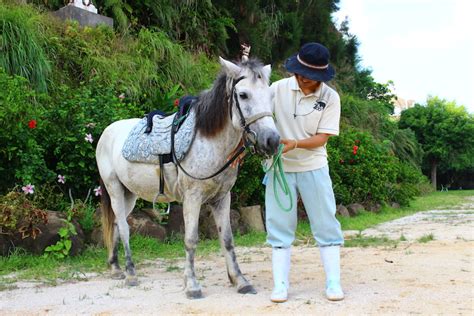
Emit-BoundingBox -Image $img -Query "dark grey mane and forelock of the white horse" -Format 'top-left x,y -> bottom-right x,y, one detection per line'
195,59 -> 263,137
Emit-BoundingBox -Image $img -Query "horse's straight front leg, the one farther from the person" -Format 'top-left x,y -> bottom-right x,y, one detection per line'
183,194 -> 202,298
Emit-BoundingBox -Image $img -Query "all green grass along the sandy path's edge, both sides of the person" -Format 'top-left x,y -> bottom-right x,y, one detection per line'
0,191 -> 474,284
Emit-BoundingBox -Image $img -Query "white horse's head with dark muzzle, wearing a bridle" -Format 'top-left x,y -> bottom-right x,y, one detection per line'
220,58 -> 280,156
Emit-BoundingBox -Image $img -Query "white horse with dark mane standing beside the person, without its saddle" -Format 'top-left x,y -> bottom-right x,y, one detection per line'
96,58 -> 280,298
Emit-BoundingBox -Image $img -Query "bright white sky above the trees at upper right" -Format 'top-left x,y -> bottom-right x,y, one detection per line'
333,0 -> 474,114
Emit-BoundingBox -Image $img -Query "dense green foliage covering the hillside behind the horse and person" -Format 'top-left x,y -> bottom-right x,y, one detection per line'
0,0 -> 436,228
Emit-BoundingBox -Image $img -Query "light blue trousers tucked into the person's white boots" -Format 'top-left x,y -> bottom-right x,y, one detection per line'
264,166 -> 344,248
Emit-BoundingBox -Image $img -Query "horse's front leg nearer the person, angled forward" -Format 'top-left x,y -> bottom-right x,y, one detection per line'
212,192 -> 257,294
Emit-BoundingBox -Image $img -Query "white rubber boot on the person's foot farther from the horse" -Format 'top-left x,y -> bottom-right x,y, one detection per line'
319,246 -> 344,301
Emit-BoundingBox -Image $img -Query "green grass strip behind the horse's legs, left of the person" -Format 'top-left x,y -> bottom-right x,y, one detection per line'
0,232 -> 265,282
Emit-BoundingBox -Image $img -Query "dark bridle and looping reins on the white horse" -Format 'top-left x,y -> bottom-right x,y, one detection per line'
171,76 -> 273,180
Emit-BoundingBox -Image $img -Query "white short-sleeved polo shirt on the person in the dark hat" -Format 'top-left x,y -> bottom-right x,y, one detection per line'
271,76 -> 341,172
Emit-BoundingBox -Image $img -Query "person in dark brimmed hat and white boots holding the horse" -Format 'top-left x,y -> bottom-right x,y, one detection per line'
264,43 -> 344,302
